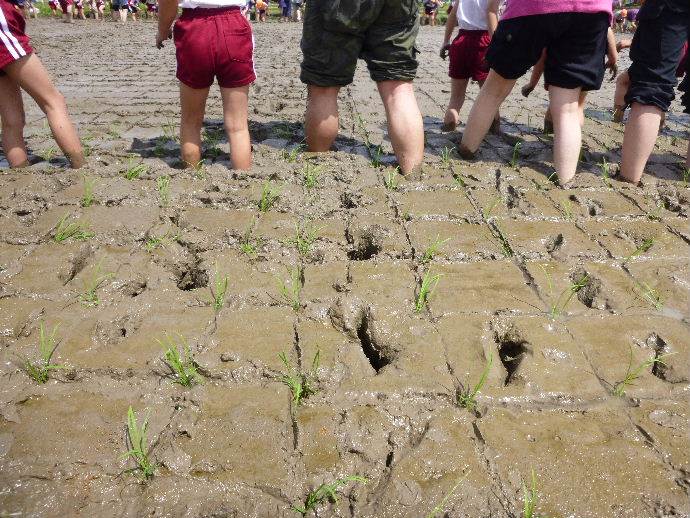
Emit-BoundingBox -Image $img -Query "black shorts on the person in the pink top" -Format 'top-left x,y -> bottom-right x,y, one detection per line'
486,12 -> 609,90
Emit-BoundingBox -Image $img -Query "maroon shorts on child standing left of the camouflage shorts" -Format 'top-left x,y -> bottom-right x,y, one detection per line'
173,7 -> 256,88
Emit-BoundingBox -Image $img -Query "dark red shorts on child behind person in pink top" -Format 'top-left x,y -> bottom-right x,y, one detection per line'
448,29 -> 491,81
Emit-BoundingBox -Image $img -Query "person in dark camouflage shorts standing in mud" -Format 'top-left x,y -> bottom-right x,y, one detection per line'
300,0 -> 424,174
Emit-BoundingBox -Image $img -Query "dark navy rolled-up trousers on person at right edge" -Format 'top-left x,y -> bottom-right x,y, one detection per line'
625,0 -> 690,113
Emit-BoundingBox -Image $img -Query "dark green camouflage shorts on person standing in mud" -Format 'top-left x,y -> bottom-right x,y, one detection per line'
300,0 -> 419,86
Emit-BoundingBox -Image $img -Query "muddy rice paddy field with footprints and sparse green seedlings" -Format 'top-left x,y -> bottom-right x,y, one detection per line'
0,20 -> 690,518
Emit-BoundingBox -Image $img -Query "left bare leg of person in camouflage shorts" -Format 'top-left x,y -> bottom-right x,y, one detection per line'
304,85 -> 340,152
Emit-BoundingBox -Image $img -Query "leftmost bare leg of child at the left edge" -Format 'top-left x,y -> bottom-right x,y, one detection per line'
0,76 -> 29,167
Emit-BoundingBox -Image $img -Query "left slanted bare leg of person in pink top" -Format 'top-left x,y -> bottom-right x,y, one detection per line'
458,70 -> 515,158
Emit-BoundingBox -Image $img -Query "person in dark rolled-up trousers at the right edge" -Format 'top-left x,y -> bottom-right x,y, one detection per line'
621,0 -> 690,184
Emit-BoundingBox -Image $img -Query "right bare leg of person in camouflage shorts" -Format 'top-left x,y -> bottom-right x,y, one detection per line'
377,81 -> 424,174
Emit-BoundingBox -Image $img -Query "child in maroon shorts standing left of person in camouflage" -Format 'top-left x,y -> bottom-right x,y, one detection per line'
156,0 -> 256,169
